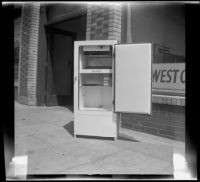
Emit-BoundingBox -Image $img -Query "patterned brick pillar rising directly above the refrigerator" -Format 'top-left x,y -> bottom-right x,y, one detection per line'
86,5 -> 122,41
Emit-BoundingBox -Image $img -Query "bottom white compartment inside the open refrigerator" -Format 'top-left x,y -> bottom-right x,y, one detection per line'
79,86 -> 112,111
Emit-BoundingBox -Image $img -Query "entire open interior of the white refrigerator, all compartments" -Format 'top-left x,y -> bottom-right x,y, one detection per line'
79,45 -> 112,111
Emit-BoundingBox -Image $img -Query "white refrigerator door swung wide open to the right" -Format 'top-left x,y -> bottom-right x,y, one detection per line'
114,43 -> 152,115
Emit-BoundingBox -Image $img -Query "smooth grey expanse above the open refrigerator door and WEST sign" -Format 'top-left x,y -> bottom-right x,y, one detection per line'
131,3 -> 185,56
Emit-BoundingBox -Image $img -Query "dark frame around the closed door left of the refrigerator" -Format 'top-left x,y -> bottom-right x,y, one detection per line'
44,24 -> 77,106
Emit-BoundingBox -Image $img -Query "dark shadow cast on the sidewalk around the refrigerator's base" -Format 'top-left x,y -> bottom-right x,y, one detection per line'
63,121 -> 139,142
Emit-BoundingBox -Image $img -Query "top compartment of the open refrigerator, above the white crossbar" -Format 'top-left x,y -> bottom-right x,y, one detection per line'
79,46 -> 112,70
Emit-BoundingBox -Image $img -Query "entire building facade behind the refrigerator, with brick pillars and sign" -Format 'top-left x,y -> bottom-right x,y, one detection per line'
15,3 -> 185,141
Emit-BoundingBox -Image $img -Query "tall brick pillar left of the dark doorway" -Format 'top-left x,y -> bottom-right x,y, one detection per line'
18,3 -> 40,105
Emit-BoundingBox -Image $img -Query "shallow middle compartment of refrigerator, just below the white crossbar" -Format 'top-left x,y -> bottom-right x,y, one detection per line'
80,73 -> 112,86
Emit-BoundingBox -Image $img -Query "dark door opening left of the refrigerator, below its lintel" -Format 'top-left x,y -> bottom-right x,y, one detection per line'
46,27 -> 76,106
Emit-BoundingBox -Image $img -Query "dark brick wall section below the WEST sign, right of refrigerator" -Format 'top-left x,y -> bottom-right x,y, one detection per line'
121,104 -> 185,141
